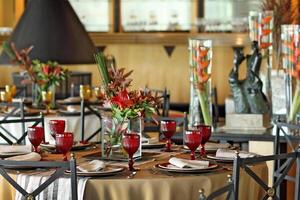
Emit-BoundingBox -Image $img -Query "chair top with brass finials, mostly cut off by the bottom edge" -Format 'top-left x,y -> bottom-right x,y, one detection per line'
199,174 -> 233,200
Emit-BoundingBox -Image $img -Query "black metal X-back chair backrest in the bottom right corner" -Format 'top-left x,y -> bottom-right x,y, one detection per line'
233,149 -> 300,200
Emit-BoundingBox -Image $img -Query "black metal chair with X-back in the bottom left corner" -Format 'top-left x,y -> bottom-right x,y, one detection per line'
0,155 -> 78,200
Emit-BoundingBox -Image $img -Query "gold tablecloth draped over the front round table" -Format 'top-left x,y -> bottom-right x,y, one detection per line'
0,150 -> 268,200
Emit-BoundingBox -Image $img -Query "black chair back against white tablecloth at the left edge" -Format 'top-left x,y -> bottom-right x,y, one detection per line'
0,111 -> 44,145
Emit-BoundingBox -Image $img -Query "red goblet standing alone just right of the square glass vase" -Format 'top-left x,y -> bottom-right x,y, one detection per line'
160,120 -> 176,152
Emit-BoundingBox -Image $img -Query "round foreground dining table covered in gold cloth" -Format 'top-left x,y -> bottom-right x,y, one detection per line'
0,144 -> 268,200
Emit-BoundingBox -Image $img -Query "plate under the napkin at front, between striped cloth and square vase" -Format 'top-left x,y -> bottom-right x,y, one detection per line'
66,165 -> 125,177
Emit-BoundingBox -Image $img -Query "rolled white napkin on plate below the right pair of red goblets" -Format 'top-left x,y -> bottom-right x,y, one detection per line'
169,157 -> 209,168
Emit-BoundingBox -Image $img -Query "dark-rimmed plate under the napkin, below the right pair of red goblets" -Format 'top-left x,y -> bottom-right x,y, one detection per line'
155,162 -> 219,173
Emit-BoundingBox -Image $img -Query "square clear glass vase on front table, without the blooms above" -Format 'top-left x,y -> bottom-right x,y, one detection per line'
101,115 -> 144,161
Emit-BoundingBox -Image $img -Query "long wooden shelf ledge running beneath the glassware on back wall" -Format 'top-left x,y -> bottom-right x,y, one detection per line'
0,32 -> 250,46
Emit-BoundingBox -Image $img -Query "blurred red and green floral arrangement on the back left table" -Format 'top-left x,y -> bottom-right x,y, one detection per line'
3,42 -> 67,107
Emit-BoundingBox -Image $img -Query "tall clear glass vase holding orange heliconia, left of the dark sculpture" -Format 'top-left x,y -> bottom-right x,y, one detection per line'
188,39 -> 212,127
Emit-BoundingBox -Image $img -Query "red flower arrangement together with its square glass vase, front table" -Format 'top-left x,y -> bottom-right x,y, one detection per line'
95,52 -> 159,160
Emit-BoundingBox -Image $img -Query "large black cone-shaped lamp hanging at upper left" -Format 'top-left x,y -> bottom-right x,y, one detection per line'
0,0 -> 96,64
